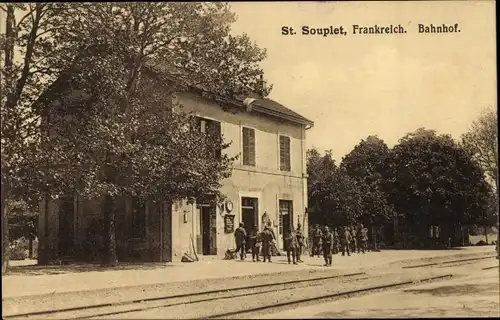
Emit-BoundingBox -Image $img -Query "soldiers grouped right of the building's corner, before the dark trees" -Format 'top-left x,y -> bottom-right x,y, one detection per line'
311,224 -> 368,266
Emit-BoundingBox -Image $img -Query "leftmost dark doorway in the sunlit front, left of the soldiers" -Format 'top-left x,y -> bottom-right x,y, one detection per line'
199,205 -> 217,255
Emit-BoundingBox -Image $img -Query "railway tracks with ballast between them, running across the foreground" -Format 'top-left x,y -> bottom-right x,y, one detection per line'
3,256 -> 493,319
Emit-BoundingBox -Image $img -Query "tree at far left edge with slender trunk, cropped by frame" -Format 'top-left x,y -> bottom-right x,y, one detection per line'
0,3 -> 74,273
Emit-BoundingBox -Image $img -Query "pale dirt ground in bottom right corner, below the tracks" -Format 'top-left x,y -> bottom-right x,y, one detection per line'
265,260 -> 500,319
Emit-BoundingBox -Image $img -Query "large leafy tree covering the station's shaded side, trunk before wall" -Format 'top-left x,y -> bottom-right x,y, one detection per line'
35,3 -> 270,265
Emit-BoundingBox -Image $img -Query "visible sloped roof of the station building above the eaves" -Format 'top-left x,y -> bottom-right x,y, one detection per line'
146,61 -> 314,126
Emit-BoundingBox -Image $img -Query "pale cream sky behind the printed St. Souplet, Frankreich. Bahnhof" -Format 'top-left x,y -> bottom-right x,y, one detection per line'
231,1 -> 497,161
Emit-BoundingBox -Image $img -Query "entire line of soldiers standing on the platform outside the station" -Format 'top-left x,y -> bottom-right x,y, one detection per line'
234,223 -> 368,266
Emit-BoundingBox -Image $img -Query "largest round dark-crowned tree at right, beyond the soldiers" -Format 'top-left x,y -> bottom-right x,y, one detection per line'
384,129 -> 488,248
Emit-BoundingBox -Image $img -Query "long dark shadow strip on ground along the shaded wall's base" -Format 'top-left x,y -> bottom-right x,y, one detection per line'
8,263 -> 176,276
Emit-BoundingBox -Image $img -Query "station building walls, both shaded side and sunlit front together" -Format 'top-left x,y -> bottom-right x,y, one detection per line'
39,89 -> 308,261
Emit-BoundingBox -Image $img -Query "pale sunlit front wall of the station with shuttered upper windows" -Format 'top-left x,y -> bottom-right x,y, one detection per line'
173,94 -> 308,257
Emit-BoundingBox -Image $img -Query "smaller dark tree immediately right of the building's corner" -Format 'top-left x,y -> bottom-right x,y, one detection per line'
307,149 -> 362,226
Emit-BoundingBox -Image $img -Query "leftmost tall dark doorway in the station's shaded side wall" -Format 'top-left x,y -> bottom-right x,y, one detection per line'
58,196 -> 75,257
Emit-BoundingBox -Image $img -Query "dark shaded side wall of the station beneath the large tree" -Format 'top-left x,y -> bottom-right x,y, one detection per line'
39,197 -> 172,263
